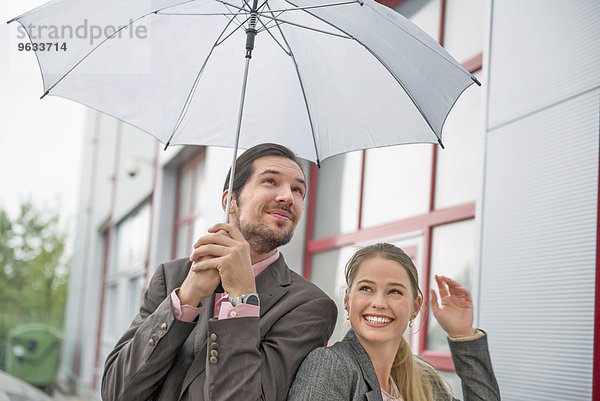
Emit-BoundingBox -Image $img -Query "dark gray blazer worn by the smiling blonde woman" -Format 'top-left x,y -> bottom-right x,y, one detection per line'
288,330 -> 500,401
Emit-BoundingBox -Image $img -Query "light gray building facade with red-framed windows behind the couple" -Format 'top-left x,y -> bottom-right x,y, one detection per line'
60,0 -> 600,401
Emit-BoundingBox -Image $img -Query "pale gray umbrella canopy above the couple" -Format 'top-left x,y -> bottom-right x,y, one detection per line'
13,0 -> 477,162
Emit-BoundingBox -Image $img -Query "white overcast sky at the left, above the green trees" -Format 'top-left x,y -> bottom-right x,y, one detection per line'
0,0 -> 86,231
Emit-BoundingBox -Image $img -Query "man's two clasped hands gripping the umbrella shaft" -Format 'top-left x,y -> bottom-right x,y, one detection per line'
190,223 -> 256,297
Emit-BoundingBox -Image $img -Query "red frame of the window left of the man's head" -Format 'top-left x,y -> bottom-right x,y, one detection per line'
171,150 -> 206,258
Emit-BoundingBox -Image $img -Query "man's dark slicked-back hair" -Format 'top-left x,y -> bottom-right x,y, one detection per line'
223,143 -> 304,198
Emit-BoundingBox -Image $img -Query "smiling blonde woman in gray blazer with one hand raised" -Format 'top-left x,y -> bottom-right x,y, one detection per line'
288,244 -> 500,401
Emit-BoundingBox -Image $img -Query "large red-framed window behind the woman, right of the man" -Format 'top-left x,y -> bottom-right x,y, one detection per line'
305,0 -> 484,382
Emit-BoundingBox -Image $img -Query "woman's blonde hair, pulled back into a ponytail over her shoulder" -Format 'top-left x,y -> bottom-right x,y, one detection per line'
345,243 -> 452,401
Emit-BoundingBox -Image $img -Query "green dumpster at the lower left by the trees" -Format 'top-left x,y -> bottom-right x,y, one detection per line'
6,323 -> 61,387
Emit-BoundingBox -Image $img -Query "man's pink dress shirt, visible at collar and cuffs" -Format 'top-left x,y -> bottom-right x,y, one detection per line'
171,250 -> 279,322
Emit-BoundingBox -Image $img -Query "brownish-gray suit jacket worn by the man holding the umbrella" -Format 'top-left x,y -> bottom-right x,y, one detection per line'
102,255 -> 337,401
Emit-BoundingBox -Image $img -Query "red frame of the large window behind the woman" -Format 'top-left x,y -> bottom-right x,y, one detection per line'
303,0 -> 483,372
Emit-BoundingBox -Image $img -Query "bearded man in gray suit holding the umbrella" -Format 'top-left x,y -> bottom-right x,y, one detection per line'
102,144 -> 337,401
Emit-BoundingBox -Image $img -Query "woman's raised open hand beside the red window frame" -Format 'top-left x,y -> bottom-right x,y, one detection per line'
431,275 -> 475,338
